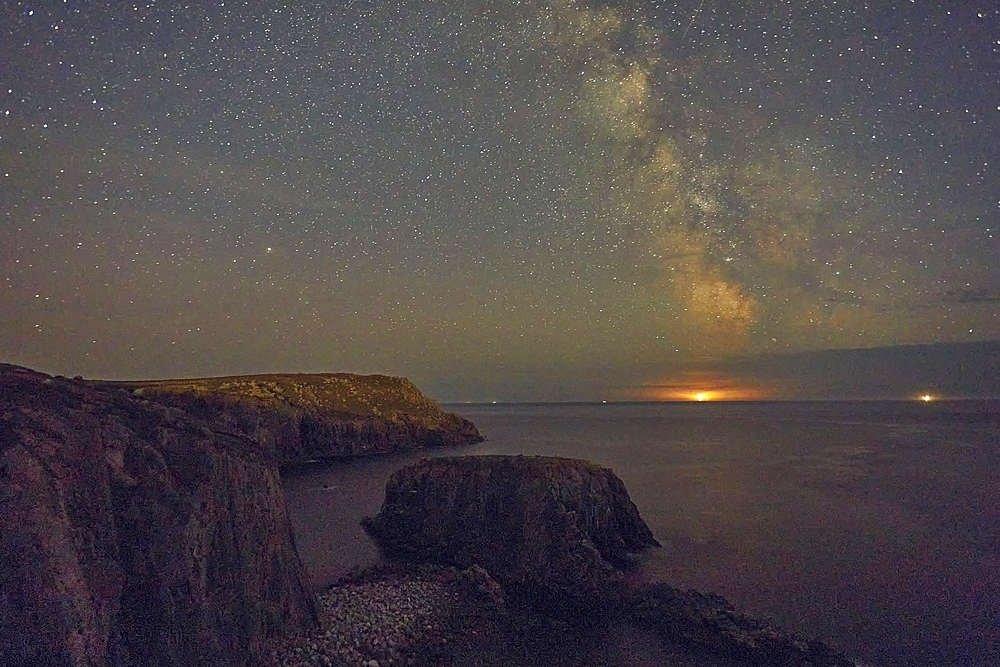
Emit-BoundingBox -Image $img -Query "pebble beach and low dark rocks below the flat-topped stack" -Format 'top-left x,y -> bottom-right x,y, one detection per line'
271,563 -> 860,667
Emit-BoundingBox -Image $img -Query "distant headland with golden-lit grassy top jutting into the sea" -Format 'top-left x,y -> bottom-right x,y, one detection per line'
105,373 -> 483,465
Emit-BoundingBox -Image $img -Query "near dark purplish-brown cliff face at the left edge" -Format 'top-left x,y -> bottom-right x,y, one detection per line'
0,365 -> 317,667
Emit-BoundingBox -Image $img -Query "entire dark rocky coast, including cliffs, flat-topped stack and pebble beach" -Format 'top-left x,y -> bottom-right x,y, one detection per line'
0,365 -> 850,667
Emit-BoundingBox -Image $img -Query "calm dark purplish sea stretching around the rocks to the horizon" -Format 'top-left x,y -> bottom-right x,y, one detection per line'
285,402 -> 1000,667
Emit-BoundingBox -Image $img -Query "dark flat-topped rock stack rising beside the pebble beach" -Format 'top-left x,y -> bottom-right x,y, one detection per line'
364,456 -> 658,609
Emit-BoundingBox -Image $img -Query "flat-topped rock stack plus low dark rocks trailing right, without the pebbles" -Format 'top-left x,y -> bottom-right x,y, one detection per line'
364,456 -> 852,667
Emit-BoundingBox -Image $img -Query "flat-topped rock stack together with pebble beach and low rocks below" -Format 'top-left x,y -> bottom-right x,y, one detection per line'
276,455 -> 853,667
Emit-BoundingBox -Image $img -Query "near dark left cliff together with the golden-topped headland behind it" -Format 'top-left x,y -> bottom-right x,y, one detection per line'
0,364 -> 481,667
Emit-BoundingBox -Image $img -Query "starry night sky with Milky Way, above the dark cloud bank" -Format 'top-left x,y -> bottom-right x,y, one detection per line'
0,0 -> 1000,401
